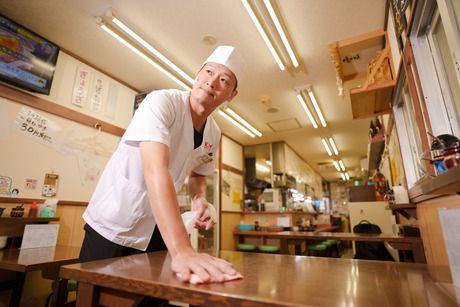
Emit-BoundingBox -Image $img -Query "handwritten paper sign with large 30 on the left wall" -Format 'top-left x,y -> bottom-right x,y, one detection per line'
14,107 -> 61,145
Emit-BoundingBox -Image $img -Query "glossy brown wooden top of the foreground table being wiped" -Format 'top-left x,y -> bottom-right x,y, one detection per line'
60,251 -> 460,307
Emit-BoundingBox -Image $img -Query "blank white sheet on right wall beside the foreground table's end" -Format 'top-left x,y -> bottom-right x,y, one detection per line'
439,208 -> 460,287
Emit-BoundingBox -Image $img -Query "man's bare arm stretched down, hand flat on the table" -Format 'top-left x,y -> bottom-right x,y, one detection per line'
139,142 -> 236,282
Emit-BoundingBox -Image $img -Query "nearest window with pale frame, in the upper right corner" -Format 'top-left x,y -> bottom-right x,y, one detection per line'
410,0 -> 460,136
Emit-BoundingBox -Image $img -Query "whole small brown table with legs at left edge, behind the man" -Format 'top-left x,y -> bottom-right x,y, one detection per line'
0,245 -> 80,306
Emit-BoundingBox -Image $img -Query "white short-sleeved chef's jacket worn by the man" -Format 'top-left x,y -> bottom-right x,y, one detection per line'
83,90 -> 221,250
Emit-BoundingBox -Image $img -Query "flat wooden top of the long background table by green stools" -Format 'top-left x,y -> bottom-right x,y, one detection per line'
233,230 -> 421,243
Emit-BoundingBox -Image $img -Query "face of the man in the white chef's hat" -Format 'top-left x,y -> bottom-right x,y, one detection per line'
192,63 -> 237,108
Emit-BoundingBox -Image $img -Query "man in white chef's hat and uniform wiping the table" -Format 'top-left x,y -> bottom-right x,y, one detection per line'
80,46 -> 244,282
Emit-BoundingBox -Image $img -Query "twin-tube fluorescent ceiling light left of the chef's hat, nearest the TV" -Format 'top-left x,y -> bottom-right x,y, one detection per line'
97,12 -> 194,90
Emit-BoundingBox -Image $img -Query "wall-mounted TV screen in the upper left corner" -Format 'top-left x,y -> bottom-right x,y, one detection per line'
0,15 -> 59,95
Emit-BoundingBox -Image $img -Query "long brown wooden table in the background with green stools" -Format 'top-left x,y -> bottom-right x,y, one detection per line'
233,230 -> 426,263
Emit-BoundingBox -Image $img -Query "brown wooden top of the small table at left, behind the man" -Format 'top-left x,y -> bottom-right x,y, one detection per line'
0,245 -> 80,272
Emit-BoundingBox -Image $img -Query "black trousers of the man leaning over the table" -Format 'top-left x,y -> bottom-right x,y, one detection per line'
80,224 -> 169,307
